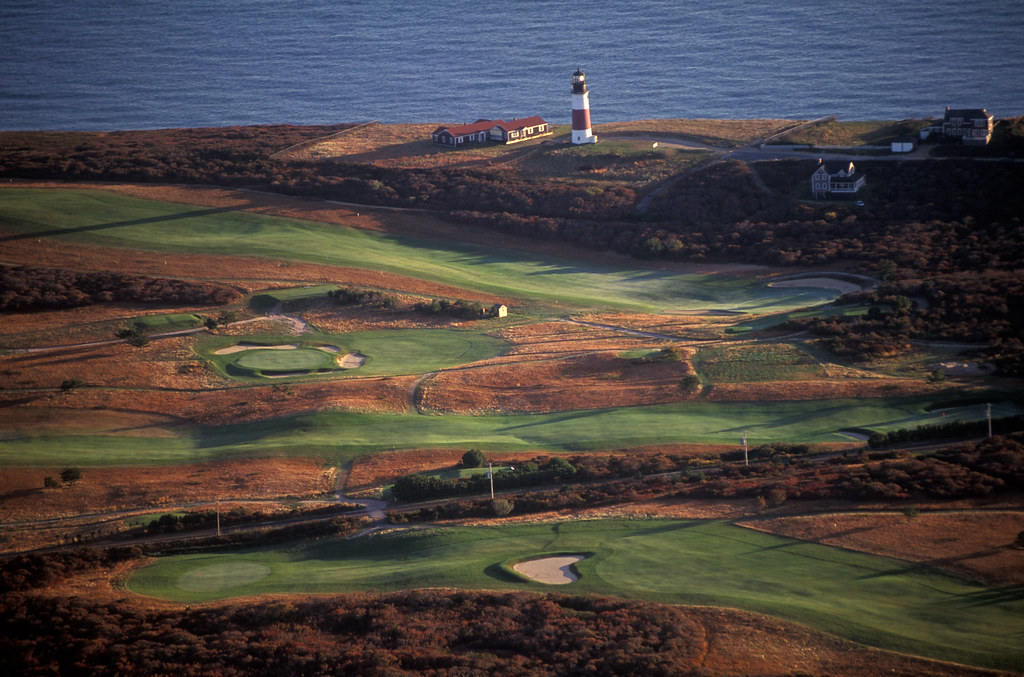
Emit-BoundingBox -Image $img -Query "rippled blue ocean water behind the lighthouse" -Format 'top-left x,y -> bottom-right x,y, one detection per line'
0,0 -> 1024,130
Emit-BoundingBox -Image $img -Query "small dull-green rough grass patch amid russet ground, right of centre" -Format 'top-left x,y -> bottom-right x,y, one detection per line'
693,343 -> 825,384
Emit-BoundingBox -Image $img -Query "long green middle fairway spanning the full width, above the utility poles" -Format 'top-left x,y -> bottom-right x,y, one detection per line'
0,397 -> 1024,466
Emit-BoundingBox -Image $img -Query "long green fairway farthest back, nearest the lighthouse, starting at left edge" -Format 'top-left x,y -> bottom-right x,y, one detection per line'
0,188 -> 837,313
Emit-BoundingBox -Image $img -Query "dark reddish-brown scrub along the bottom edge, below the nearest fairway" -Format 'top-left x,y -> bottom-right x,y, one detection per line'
0,590 -> 996,677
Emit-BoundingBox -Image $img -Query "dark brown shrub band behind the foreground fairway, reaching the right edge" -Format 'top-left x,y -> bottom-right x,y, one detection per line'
388,432 -> 1024,523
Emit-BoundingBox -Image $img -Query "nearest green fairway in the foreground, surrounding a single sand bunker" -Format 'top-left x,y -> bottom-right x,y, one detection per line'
127,520 -> 1024,670
